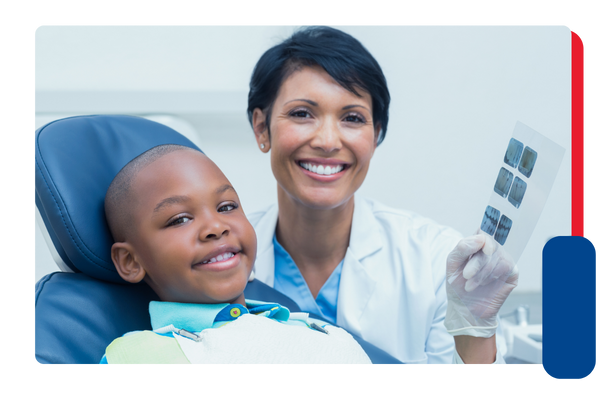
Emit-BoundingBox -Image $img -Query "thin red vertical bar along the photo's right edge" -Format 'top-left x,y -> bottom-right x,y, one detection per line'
571,29 -> 587,236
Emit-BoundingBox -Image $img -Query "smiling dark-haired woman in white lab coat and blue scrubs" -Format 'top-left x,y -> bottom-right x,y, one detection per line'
247,27 -> 518,366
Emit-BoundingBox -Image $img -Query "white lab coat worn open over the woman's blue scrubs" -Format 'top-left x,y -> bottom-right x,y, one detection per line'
248,196 -> 462,366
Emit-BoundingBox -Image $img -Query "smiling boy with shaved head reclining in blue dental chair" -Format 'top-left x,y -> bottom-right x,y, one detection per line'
100,145 -> 371,366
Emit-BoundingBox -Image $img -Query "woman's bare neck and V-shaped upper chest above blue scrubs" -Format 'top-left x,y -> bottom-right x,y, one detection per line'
276,187 -> 354,297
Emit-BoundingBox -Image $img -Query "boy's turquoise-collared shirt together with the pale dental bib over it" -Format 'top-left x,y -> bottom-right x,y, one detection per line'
100,299 -> 372,367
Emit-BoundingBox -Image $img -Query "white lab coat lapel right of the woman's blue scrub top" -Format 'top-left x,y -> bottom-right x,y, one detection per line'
337,195 -> 383,336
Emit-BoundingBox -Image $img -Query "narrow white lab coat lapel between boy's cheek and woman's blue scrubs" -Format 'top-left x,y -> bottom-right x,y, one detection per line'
254,204 -> 279,287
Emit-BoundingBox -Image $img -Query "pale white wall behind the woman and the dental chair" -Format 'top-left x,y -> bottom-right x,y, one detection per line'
32,24 -> 571,291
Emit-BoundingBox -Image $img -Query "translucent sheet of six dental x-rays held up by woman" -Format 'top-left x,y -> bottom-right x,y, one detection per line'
480,122 -> 565,263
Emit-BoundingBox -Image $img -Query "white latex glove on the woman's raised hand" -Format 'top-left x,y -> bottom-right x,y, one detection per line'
444,229 -> 519,338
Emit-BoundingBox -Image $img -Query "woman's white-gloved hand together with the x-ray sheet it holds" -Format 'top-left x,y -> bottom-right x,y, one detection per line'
445,122 -> 565,337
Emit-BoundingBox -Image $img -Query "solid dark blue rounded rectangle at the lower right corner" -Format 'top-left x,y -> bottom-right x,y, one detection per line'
542,236 -> 598,382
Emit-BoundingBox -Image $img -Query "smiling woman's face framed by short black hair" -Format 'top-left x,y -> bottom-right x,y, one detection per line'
255,67 -> 379,209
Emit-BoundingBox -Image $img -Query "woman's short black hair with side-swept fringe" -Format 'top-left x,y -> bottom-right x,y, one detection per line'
247,26 -> 390,145
